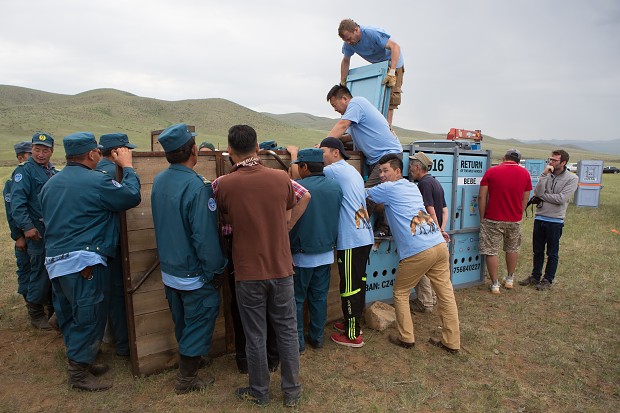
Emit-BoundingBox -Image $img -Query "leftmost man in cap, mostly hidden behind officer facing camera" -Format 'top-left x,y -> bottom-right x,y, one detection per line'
2,142 -> 32,301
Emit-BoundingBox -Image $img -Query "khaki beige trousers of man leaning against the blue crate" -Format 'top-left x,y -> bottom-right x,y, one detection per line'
394,243 -> 461,350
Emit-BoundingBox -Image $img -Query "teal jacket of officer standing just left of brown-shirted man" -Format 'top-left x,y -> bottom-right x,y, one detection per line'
151,164 -> 227,290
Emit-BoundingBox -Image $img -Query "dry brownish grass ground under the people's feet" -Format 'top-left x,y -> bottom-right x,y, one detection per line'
0,168 -> 620,413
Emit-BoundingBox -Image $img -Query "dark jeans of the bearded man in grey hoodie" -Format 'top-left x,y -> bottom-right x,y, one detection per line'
532,219 -> 564,283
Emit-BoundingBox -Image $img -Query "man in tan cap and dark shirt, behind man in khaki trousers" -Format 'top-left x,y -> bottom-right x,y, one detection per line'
409,152 -> 450,313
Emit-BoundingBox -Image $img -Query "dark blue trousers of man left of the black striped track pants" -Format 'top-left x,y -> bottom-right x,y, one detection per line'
293,264 -> 331,351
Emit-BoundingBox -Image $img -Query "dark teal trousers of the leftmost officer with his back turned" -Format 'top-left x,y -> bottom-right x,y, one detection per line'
52,264 -> 110,364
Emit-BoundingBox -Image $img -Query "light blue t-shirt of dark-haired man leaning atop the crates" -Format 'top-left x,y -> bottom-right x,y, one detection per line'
342,96 -> 403,165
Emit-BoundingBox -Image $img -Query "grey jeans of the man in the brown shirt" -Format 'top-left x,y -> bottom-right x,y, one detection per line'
236,275 -> 301,402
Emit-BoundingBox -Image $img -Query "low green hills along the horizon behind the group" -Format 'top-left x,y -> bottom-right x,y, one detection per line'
0,85 -> 620,163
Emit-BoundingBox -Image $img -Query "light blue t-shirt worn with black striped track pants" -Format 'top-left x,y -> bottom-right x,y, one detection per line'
323,159 -> 374,251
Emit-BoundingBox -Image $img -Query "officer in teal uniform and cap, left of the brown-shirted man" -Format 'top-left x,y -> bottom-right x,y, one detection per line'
151,123 -> 226,394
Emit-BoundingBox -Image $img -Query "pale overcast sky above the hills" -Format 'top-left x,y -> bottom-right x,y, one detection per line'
0,0 -> 620,140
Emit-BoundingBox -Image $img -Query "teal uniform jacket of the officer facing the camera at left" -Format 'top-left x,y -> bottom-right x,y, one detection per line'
11,158 -> 57,235
